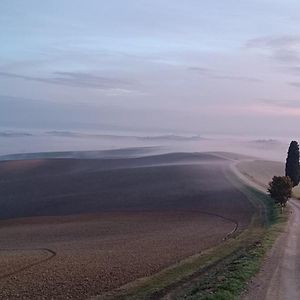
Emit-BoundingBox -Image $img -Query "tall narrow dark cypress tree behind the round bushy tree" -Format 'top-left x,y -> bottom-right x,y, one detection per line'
285,141 -> 300,187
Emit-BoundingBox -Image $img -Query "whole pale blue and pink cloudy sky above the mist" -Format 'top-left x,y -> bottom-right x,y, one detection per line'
0,0 -> 300,136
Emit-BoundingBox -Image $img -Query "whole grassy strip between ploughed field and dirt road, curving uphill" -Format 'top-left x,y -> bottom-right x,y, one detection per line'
92,174 -> 286,300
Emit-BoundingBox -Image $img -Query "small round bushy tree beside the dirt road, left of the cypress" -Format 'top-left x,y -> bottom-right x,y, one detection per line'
268,176 -> 293,207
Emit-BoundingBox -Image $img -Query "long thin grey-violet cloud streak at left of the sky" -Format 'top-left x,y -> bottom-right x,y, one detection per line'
0,72 -> 135,91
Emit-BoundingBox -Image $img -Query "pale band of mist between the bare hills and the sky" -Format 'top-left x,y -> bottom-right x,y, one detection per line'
0,130 -> 289,161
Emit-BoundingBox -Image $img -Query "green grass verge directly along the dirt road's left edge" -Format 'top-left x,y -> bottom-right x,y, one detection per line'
171,207 -> 287,300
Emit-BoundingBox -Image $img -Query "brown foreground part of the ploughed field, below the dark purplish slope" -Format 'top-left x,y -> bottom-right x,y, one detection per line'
0,212 -> 235,299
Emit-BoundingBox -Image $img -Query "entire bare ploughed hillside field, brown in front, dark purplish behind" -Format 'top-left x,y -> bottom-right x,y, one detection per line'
0,153 -> 254,299
